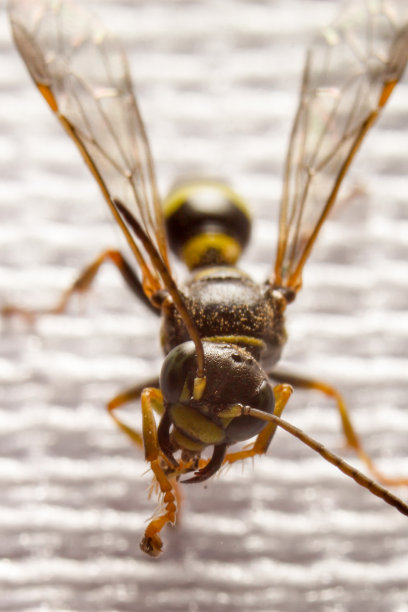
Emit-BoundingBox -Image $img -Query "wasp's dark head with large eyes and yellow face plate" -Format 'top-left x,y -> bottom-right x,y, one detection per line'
160,342 -> 274,451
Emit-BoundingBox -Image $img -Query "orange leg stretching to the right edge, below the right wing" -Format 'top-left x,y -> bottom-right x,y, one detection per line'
268,371 -> 408,487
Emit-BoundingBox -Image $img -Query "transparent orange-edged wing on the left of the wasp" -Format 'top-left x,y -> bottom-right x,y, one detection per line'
8,0 -> 169,296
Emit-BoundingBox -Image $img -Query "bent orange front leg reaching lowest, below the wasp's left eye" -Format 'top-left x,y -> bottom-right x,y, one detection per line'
140,388 -> 177,557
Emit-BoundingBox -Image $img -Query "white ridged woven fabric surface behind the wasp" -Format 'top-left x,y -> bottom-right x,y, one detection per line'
0,0 -> 408,612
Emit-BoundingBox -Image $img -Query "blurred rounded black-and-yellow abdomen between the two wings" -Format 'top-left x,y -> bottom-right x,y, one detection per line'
164,181 -> 251,269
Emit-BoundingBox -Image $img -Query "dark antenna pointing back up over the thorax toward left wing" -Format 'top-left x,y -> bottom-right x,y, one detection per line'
113,199 -> 205,382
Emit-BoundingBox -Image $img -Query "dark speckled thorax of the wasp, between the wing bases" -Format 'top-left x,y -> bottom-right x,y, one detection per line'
162,266 -> 287,368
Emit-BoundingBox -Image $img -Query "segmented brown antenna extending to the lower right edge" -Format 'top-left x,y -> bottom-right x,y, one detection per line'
242,406 -> 408,516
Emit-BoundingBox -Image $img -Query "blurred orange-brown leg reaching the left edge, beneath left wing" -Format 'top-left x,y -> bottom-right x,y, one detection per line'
1,250 -> 159,321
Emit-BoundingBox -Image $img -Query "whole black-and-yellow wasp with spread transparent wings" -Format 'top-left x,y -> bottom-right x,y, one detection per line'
3,0 -> 408,556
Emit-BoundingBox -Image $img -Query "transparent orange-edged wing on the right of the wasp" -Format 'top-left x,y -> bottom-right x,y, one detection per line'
273,0 -> 408,291
